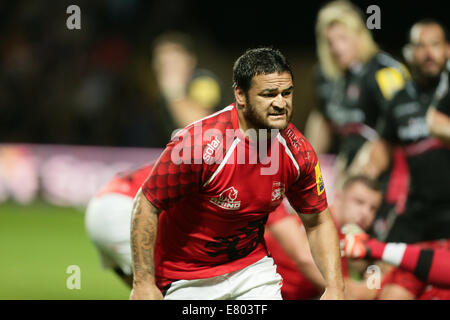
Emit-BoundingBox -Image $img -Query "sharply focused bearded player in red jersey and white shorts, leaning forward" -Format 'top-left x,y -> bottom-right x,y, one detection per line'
130,48 -> 344,299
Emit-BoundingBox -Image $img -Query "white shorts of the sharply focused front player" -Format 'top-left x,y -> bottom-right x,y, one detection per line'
164,257 -> 282,300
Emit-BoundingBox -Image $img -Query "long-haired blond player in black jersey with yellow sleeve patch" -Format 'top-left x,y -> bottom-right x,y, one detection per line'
305,0 -> 409,240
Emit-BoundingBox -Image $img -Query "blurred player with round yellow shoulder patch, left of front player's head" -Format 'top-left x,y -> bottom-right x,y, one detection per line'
152,32 -> 221,142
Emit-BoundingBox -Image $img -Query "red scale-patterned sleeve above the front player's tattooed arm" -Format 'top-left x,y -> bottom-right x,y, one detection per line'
142,127 -> 203,210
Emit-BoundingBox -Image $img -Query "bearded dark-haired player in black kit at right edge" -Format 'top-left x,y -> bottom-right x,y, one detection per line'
352,19 -> 450,299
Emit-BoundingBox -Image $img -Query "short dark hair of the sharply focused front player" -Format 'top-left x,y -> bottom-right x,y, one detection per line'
233,47 -> 294,93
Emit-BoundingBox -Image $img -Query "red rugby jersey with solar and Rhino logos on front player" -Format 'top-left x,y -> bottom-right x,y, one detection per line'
142,105 -> 327,286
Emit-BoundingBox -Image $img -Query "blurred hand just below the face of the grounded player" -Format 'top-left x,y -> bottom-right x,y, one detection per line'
341,224 -> 369,259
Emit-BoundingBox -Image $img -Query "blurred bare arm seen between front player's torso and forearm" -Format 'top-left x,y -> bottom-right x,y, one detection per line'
269,217 -> 325,290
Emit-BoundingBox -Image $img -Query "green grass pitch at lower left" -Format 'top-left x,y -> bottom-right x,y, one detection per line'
0,201 -> 130,300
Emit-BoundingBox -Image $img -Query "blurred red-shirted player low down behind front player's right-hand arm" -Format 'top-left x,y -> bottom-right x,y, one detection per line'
265,176 -> 382,300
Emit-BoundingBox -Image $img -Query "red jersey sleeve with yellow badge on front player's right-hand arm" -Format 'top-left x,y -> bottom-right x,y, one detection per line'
286,128 -> 328,214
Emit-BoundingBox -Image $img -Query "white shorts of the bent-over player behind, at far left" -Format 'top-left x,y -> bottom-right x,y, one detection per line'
85,193 -> 134,275
